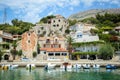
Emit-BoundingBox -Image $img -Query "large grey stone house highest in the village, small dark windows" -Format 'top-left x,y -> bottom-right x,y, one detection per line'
33,15 -> 69,37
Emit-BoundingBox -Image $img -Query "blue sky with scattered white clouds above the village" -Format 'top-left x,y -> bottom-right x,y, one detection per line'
0,0 -> 120,24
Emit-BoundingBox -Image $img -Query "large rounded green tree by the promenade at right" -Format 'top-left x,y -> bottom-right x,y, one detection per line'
99,44 -> 114,60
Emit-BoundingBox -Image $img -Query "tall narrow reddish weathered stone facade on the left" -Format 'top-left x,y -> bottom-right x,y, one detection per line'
21,31 -> 37,58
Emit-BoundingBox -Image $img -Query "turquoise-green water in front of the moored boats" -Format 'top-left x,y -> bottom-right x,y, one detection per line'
0,68 -> 120,80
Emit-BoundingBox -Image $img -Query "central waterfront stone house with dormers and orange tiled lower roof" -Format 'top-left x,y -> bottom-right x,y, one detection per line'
39,37 -> 68,60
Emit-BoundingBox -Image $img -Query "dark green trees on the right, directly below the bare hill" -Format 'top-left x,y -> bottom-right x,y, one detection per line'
82,13 -> 120,28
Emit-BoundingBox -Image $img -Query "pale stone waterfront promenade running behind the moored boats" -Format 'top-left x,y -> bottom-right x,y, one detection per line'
0,60 -> 120,67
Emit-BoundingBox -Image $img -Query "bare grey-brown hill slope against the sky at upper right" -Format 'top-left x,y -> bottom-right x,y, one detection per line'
68,8 -> 120,20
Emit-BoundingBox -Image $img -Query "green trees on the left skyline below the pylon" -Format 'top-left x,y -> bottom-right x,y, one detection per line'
0,19 -> 33,34
